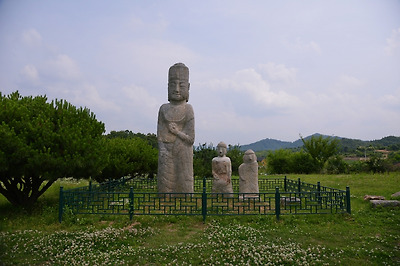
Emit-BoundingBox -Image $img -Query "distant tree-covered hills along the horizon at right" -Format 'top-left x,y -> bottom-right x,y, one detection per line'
240,133 -> 400,152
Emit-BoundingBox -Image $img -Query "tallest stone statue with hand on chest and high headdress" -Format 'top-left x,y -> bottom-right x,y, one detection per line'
157,63 -> 194,193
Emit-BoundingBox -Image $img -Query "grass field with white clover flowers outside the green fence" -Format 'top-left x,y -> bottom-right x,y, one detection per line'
0,173 -> 400,265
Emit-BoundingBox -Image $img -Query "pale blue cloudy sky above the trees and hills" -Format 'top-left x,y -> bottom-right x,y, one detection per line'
0,0 -> 400,145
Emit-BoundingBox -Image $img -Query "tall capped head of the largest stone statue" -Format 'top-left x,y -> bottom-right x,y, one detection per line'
168,63 -> 190,102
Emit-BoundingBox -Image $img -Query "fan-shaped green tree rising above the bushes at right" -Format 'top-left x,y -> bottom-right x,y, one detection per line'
300,135 -> 339,172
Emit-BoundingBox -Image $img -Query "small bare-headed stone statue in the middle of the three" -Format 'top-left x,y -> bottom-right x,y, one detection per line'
212,141 -> 233,193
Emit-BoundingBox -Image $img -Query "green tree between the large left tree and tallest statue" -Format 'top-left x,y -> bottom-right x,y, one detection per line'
96,137 -> 158,182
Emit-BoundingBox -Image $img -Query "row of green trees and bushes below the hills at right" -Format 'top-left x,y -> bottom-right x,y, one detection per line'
260,135 -> 400,174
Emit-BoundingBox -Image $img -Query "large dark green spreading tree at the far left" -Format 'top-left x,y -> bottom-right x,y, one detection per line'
0,91 -> 104,208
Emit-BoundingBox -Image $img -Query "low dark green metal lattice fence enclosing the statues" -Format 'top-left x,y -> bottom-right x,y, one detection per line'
59,177 -> 351,222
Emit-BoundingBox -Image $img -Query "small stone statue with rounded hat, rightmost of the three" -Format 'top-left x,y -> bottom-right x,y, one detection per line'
239,150 -> 259,197
